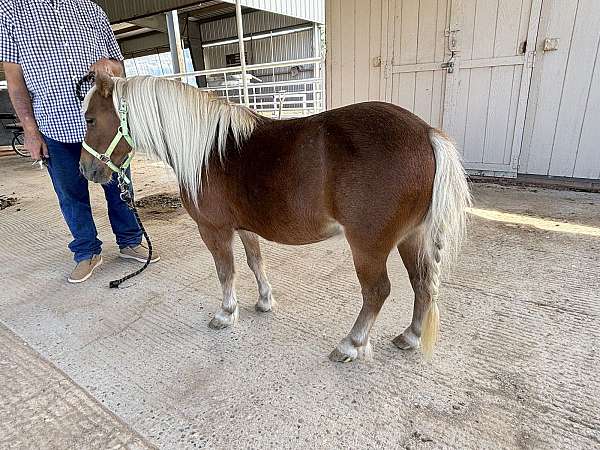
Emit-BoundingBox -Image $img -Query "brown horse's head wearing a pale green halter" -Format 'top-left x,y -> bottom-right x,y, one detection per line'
79,73 -> 132,183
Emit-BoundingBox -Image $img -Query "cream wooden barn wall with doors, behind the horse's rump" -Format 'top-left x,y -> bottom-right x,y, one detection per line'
326,0 -> 600,185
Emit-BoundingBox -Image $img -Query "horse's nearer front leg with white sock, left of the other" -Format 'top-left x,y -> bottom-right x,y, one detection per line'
198,225 -> 239,330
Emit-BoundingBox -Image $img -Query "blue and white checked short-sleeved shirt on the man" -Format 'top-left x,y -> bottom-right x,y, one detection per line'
0,0 -> 123,142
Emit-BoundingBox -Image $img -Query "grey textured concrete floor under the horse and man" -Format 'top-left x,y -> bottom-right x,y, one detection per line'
0,157 -> 600,449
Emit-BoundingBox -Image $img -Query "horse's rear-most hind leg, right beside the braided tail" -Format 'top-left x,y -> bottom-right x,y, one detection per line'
393,230 -> 438,350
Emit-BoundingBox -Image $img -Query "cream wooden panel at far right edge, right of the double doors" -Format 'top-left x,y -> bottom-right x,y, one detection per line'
519,0 -> 600,179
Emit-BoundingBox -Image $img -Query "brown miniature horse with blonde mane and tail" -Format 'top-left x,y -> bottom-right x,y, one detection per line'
80,74 -> 470,362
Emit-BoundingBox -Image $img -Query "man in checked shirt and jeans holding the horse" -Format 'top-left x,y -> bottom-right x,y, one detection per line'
0,0 -> 160,283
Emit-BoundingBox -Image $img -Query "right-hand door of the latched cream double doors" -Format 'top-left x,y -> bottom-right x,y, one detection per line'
445,0 -> 541,176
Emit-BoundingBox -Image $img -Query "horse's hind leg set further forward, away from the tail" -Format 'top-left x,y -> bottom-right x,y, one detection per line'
329,240 -> 390,362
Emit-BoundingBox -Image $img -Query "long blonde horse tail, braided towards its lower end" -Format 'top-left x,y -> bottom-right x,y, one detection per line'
421,128 -> 471,358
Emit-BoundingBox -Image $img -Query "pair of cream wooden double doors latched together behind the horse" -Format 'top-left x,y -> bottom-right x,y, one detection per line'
382,0 -> 542,176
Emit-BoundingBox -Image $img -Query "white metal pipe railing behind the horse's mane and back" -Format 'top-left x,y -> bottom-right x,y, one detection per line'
164,58 -> 325,117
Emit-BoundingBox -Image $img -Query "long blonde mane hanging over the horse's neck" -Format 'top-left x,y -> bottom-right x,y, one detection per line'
92,76 -> 258,198
